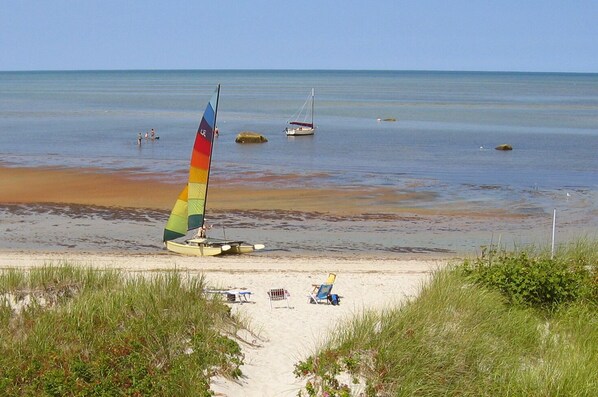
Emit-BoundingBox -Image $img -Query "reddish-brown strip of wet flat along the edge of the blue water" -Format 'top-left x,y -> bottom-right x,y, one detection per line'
0,167 -> 521,217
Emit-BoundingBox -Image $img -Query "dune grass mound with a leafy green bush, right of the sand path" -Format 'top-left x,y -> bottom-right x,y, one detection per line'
295,242 -> 598,397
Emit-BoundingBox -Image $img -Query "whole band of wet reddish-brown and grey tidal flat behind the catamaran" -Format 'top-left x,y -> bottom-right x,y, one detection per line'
0,166 -> 596,256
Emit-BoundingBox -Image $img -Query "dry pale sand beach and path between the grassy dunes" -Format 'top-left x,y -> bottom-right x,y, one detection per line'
0,251 -> 447,397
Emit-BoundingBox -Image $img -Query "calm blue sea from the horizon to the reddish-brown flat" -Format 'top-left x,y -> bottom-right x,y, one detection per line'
0,70 -> 598,215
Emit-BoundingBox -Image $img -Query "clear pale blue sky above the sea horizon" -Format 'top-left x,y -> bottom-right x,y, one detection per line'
0,0 -> 598,73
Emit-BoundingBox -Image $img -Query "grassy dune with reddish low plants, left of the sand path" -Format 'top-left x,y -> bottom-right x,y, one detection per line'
0,264 -> 243,396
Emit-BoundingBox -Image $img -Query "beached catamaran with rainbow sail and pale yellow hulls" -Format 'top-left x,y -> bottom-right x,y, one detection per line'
163,85 -> 264,256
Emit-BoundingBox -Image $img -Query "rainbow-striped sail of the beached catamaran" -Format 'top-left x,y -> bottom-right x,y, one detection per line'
164,85 -> 220,241
